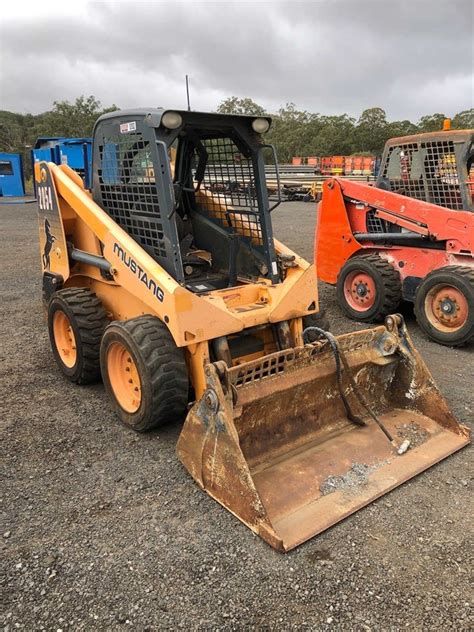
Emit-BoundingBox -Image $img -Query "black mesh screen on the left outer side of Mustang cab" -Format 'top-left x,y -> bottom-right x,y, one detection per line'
98,133 -> 166,258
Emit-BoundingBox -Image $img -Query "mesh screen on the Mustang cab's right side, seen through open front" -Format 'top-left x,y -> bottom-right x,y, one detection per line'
197,138 -> 262,245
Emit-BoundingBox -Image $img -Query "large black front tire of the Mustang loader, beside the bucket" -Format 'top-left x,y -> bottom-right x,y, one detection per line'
100,315 -> 189,432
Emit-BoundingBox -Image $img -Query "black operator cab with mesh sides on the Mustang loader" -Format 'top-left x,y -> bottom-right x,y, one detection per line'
92,109 -> 280,293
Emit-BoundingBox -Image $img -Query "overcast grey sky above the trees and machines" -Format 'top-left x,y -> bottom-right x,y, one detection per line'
0,0 -> 473,120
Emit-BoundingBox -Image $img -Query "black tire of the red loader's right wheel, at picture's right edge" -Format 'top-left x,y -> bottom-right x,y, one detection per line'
415,266 -> 474,347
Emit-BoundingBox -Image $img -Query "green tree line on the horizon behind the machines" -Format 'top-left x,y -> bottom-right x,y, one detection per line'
0,96 -> 474,176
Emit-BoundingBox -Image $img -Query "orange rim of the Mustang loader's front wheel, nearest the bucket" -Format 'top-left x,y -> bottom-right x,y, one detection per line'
107,342 -> 142,413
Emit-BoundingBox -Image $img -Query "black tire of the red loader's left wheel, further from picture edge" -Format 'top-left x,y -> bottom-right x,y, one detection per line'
336,254 -> 402,323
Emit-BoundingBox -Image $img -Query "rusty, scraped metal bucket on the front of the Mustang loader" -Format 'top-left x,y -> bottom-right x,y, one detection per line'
177,315 -> 469,551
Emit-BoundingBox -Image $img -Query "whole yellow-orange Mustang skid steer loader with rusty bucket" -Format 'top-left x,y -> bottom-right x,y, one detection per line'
35,109 -> 469,550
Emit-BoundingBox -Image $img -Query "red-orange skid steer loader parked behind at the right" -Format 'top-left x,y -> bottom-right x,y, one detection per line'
315,126 -> 474,346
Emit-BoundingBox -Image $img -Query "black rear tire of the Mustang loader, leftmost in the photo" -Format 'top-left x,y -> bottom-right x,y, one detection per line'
48,288 -> 109,384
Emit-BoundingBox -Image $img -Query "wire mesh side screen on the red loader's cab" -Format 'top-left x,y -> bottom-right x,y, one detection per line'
382,141 -> 463,210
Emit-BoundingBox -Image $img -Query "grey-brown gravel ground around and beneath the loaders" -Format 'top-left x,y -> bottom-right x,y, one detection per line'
0,203 -> 474,631
